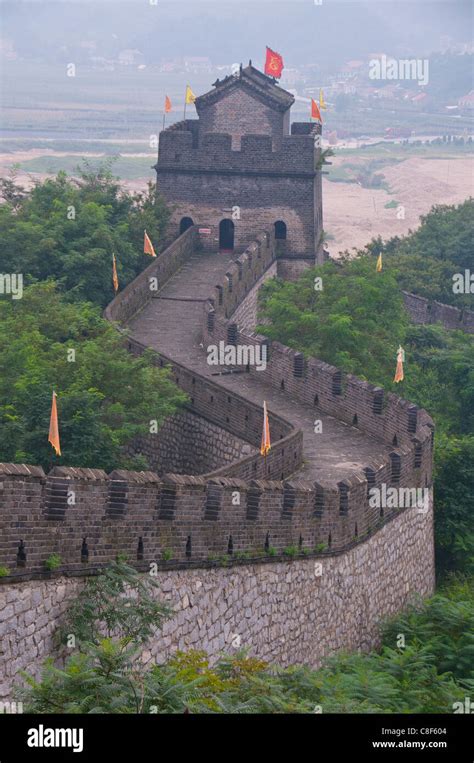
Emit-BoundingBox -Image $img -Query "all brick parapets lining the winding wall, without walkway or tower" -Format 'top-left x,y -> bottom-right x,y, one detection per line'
0,228 -> 433,580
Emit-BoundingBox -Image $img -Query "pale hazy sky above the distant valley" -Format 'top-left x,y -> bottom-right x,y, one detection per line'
0,0 -> 472,66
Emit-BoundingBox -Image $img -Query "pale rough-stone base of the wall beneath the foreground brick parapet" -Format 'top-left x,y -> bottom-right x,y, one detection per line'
0,496 -> 435,700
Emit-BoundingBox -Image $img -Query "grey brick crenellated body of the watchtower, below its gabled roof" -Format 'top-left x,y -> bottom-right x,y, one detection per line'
156,121 -> 322,257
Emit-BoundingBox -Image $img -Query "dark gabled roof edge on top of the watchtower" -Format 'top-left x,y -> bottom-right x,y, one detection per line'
195,62 -> 295,113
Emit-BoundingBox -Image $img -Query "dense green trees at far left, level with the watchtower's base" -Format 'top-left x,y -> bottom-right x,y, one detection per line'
0,162 -> 169,306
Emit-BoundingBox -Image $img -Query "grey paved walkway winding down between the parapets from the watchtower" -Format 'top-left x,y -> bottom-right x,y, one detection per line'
129,254 -> 387,482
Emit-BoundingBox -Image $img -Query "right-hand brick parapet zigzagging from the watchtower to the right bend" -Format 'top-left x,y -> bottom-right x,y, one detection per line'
203,239 -> 434,448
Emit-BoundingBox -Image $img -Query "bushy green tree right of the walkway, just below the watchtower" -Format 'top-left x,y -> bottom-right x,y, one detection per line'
259,256 -> 408,386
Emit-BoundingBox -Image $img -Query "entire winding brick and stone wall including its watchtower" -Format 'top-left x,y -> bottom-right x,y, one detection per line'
0,67 -> 434,698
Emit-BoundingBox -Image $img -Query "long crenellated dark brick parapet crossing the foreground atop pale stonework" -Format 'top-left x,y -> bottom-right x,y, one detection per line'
0,449 -> 430,582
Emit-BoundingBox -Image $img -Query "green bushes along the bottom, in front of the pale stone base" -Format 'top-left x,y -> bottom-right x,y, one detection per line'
19,562 -> 466,714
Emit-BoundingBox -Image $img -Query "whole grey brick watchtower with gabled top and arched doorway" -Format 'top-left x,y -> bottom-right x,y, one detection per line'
155,63 -> 322,261
